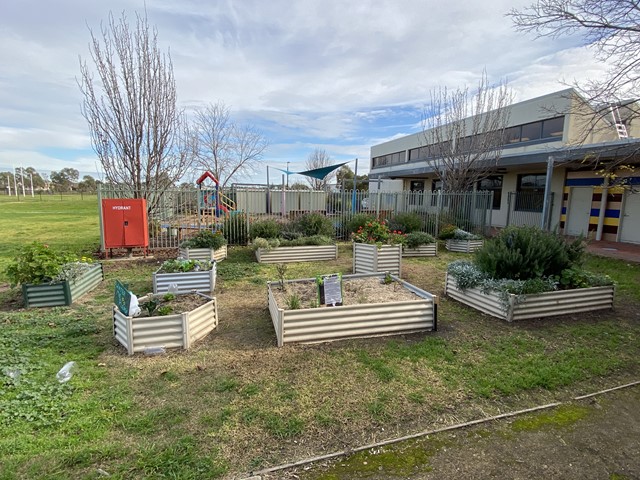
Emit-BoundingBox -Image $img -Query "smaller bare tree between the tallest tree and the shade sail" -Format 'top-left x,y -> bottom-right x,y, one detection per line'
192,102 -> 268,187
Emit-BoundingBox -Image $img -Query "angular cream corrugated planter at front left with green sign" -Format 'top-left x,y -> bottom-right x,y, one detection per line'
113,296 -> 218,355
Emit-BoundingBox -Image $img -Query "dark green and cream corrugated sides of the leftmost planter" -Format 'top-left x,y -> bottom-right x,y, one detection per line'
22,263 -> 104,308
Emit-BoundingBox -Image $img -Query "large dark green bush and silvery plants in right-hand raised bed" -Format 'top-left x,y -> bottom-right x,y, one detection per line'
447,227 -> 613,319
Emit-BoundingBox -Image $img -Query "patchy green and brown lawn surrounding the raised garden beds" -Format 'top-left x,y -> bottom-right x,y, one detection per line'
0,201 -> 640,479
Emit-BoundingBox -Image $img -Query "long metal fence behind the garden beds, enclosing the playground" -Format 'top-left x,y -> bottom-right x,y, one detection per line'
98,185 -> 493,249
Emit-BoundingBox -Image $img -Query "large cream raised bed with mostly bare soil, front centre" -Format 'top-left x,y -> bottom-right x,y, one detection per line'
267,273 -> 437,347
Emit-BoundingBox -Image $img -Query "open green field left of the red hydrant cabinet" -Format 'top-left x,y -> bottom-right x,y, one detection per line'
0,195 -> 100,281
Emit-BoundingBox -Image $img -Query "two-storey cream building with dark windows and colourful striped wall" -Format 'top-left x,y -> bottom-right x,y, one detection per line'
369,89 -> 640,243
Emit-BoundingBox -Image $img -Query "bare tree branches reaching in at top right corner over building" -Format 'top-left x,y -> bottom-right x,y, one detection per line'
508,0 -> 640,185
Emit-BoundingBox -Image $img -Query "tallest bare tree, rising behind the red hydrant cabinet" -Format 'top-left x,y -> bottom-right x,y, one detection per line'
78,9 -> 192,211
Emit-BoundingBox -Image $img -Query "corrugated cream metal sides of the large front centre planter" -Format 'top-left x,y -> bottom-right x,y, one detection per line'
267,273 -> 438,347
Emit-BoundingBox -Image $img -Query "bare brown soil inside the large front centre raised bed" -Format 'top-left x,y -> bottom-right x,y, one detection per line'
272,277 -> 418,310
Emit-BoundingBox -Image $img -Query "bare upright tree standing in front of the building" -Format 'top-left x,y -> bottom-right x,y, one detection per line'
421,73 -> 512,191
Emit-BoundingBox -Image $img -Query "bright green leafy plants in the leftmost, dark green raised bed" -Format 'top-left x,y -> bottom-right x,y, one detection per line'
6,242 -> 93,286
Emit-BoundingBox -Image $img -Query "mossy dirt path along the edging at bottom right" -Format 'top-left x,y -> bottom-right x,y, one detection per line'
262,385 -> 640,480
